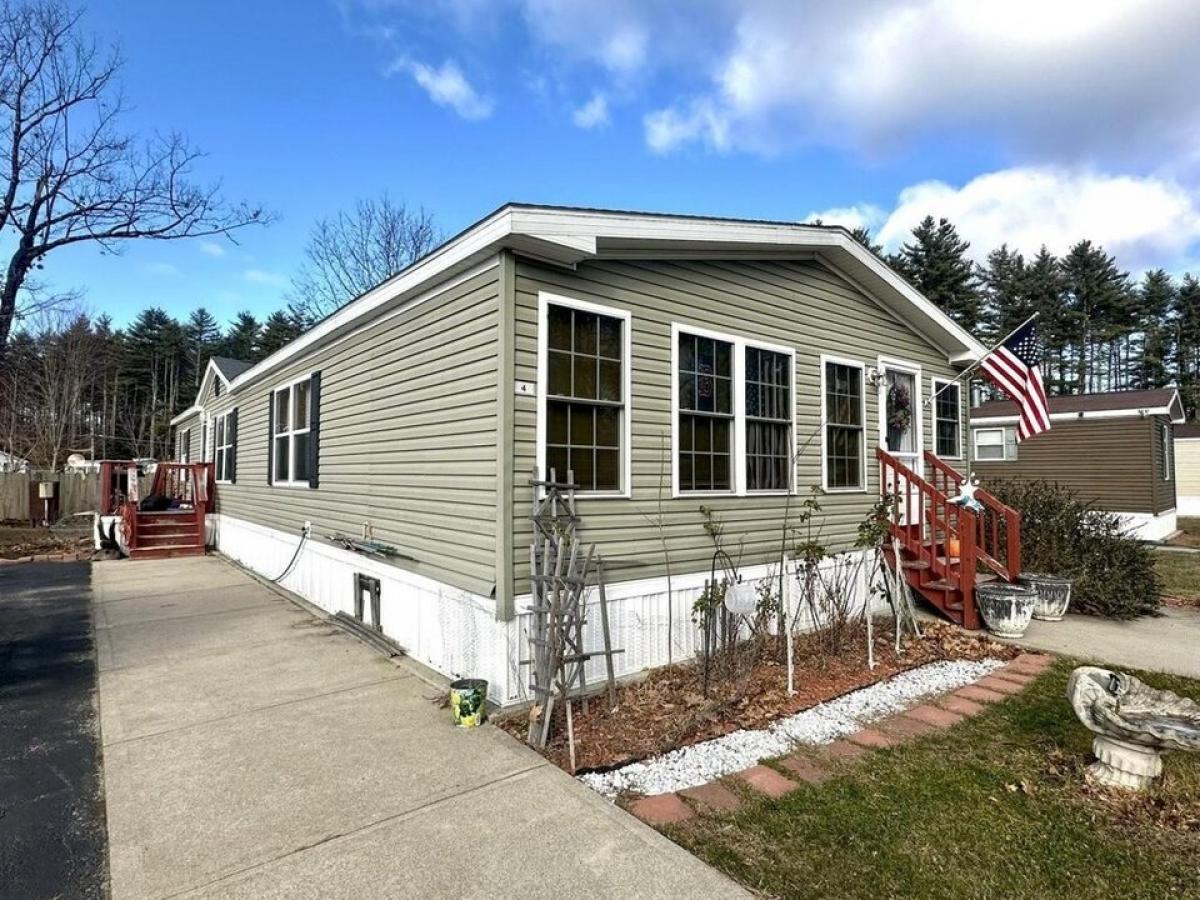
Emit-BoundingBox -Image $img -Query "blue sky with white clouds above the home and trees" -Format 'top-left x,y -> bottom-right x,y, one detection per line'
43,0 -> 1200,331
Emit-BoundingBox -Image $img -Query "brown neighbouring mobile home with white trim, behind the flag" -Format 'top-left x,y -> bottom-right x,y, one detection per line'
971,388 -> 1183,540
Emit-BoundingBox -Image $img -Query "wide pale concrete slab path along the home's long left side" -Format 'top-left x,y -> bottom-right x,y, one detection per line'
92,557 -> 744,900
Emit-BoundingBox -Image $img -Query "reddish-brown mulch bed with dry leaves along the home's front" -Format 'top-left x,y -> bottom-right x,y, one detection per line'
494,623 -> 1018,773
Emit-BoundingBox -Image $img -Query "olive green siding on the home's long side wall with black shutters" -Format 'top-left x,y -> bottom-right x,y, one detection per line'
206,266 -> 499,596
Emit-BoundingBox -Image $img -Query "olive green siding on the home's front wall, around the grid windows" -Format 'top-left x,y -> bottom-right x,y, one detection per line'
511,259 -> 965,594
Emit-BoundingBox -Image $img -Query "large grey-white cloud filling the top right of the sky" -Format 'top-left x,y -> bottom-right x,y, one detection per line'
646,0 -> 1200,160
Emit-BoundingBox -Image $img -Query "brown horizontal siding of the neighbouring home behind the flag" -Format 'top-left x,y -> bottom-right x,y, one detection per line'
972,418 -> 1175,514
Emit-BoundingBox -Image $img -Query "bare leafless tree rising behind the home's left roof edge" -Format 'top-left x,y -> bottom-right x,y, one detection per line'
289,194 -> 442,322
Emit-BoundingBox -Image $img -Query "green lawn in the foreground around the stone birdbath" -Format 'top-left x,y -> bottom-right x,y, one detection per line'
665,662 -> 1200,898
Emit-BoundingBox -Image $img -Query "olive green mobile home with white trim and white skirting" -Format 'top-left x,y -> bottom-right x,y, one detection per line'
174,205 -> 983,701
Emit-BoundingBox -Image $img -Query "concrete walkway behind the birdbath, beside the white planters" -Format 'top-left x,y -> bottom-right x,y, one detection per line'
1006,606 -> 1200,678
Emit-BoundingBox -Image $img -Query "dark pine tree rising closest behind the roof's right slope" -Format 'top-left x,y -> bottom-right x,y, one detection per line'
889,216 -> 983,332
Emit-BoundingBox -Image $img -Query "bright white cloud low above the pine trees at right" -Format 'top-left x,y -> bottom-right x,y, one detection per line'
806,167 -> 1200,271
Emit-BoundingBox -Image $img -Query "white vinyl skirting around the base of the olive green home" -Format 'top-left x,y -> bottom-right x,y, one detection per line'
216,516 -> 882,703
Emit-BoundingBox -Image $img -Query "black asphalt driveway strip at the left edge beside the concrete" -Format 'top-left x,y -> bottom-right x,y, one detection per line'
0,563 -> 106,900
